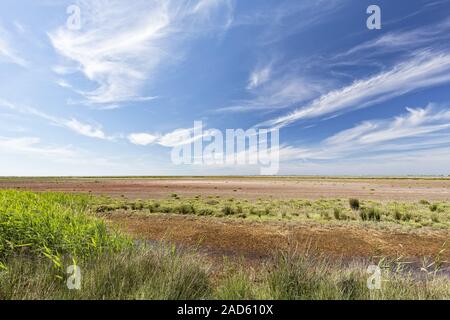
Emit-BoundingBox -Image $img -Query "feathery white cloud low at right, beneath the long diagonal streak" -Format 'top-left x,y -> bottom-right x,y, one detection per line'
282,104 -> 450,161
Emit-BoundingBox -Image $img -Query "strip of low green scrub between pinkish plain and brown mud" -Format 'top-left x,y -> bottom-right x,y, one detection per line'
94,194 -> 450,229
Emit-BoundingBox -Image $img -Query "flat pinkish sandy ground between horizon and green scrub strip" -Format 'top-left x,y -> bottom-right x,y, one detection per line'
0,178 -> 450,201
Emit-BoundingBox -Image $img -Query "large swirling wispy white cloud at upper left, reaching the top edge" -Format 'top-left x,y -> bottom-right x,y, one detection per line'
49,0 -> 232,104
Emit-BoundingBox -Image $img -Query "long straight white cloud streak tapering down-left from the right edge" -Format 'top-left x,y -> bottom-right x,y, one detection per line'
265,51 -> 450,127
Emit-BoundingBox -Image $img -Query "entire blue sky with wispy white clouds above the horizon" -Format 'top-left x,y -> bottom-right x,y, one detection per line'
0,0 -> 450,176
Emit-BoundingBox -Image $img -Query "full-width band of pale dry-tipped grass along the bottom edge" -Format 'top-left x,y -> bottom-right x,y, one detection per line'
0,245 -> 450,300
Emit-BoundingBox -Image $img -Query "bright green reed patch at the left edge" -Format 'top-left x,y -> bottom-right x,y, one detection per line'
0,191 -> 130,266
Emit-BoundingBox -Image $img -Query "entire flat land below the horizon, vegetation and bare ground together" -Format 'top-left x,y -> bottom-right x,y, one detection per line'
0,177 -> 450,300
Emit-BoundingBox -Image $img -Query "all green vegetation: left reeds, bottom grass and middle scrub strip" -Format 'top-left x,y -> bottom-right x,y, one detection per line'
0,191 -> 450,299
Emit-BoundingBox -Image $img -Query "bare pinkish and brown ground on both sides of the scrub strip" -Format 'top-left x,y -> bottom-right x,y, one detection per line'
0,177 -> 450,261
